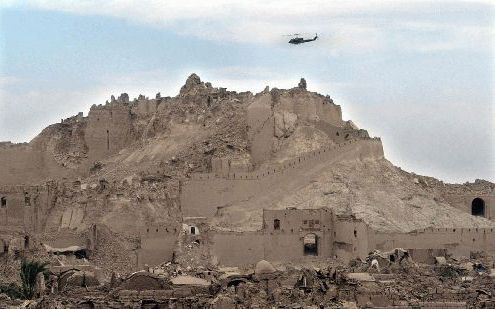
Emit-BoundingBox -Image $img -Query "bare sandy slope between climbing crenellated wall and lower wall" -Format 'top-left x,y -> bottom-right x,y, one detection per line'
210,144 -> 495,232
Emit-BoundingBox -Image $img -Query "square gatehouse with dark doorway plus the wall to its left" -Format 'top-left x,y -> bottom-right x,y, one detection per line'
210,208 -> 333,266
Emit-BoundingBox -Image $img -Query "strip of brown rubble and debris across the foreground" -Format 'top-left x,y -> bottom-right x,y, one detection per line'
3,249 -> 495,308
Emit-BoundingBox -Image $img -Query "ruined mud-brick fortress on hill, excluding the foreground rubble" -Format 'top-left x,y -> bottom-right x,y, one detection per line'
0,74 -> 495,272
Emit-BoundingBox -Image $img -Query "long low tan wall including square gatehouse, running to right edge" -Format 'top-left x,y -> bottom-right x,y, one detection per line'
211,214 -> 495,266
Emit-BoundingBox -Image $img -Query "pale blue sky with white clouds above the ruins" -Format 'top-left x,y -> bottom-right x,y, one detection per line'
0,0 -> 495,182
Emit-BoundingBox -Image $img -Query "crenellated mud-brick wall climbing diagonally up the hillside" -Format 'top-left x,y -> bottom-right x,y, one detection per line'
181,139 -> 383,217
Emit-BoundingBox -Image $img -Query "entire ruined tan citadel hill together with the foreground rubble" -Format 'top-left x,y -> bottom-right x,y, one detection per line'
0,74 -> 495,309
